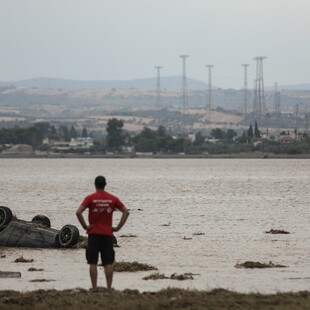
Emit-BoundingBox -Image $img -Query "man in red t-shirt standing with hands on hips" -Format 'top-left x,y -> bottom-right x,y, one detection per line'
76,176 -> 129,291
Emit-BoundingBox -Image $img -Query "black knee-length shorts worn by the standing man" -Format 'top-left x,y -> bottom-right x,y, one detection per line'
86,234 -> 115,266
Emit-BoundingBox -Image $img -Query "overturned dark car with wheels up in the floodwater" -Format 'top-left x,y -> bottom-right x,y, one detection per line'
0,206 -> 81,248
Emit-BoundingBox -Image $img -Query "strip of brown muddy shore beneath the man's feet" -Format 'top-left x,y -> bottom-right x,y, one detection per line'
0,288 -> 310,310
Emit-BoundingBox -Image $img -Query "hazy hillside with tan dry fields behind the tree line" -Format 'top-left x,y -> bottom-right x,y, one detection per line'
0,82 -> 310,132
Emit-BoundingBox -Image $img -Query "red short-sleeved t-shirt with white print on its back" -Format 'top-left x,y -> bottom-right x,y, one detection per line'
82,191 -> 124,236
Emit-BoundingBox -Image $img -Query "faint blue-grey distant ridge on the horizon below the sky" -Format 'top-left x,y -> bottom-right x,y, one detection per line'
0,76 -> 207,90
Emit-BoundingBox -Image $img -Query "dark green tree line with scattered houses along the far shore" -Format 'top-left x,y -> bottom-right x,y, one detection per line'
0,118 -> 310,154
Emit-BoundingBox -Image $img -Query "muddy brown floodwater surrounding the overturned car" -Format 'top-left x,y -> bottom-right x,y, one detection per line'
0,159 -> 310,293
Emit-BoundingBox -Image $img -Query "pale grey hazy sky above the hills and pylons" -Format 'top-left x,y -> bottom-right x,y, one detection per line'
0,0 -> 310,88
